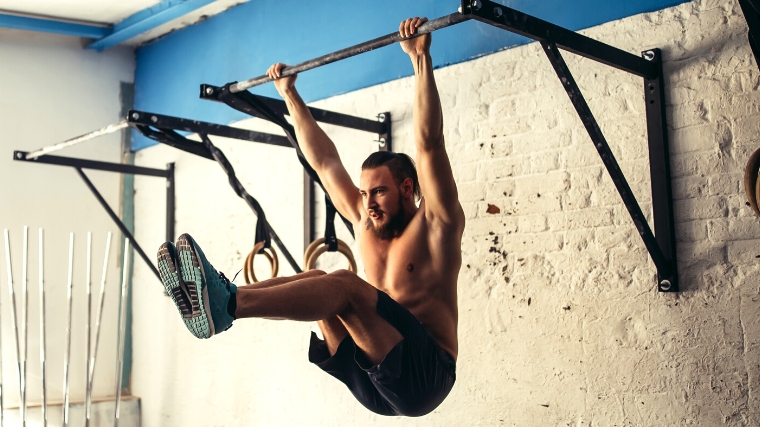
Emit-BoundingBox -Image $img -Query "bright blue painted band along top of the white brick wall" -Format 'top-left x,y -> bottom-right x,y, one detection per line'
132,0 -> 686,150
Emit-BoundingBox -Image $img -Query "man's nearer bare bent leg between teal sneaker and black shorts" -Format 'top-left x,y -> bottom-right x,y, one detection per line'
235,270 -> 402,364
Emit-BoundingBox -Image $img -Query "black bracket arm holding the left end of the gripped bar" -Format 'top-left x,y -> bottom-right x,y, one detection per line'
201,84 -> 388,135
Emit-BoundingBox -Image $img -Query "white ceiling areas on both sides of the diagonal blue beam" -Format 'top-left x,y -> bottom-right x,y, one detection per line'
0,0 -> 248,46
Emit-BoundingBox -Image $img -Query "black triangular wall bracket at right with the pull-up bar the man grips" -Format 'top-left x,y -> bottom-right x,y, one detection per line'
201,0 -> 676,292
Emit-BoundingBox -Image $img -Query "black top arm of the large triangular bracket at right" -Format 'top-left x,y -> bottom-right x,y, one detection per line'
462,0 -> 657,78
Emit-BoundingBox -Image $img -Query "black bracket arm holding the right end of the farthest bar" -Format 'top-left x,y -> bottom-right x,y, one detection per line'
127,110 -> 292,148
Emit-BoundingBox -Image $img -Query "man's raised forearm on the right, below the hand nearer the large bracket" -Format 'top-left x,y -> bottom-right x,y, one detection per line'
410,54 -> 443,149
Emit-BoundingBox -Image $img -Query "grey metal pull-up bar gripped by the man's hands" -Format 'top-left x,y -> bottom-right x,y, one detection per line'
230,12 -> 470,93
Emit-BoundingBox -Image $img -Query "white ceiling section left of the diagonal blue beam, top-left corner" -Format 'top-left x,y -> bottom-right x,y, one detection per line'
0,0 -> 161,24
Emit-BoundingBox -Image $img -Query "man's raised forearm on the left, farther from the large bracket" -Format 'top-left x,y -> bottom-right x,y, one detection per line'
281,88 -> 340,173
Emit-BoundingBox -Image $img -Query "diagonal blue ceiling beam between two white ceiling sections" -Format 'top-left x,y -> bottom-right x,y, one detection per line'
87,0 -> 216,51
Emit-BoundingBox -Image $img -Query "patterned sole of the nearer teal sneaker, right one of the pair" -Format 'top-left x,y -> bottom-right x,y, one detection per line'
177,234 -> 215,339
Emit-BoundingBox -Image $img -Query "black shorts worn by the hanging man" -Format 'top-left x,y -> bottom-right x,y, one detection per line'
309,291 -> 456,417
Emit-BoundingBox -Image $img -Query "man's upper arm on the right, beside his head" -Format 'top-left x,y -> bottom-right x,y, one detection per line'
417,146 -> 461,222
